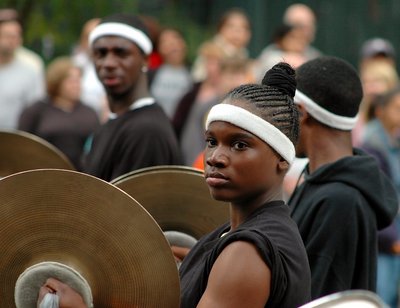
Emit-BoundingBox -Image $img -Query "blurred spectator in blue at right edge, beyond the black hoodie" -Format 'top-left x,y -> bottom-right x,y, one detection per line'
362,87 -> 400,308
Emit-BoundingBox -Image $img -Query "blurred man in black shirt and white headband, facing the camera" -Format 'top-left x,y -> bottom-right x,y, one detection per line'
85,14 -> 181,181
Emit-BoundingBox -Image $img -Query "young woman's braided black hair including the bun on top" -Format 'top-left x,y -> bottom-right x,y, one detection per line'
226,62 -> 299,144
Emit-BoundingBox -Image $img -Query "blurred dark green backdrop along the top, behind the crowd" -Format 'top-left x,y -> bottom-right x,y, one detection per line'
5,0 -> 400,69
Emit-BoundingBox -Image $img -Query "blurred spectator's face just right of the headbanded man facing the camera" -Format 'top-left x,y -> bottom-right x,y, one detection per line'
158,30 -> 186,65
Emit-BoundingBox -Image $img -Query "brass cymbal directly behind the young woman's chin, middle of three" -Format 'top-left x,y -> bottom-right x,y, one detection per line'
111,166 -> 229,239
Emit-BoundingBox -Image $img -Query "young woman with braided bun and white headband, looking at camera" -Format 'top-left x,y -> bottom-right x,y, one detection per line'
180,63 -> 310,308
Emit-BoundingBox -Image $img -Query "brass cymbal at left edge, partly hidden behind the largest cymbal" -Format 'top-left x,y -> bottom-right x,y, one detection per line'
0,130 -> 75,177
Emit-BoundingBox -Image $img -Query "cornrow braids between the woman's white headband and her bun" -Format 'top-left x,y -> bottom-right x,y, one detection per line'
226,84 -> 299,144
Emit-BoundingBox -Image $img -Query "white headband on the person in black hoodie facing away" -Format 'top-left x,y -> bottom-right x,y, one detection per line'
294,90 -> 357,130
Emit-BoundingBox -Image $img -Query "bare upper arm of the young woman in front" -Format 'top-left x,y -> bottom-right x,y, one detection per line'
197,241 -> 271,308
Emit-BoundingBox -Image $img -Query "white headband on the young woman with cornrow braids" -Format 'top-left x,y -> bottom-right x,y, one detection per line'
206,103 -> 296,164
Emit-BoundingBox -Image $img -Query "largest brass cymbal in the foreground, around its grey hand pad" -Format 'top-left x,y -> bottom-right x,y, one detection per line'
0,169 -> 180,308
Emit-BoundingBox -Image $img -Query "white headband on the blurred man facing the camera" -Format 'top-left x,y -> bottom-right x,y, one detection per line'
89,22 -> 153,55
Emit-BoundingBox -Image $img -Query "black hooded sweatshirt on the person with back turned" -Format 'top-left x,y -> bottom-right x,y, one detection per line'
289,150 -> 398,299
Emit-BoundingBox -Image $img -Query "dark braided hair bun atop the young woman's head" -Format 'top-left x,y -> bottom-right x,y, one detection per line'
261,62 -> 296,98
